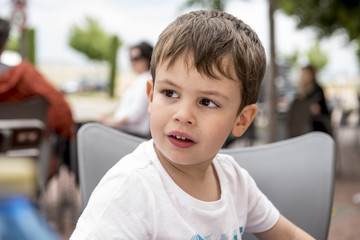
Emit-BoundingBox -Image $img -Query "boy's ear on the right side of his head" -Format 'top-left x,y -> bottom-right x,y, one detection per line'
231,104 -> 258,137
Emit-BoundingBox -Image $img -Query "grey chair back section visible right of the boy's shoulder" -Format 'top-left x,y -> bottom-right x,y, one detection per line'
221,132 -> 335,239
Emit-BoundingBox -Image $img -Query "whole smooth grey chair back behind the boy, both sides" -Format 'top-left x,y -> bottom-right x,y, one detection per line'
78,123 -> 335,239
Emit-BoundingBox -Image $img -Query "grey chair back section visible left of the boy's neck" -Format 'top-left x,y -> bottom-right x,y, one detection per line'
77,123 -> 145,208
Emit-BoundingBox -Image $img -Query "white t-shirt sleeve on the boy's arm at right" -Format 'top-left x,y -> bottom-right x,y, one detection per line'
245,172 -> 280,233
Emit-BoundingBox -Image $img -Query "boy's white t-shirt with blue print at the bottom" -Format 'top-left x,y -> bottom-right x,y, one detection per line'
70,140 -> 279,240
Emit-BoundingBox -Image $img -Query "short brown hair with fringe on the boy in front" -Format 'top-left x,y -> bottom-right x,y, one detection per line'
150,10 -> 266,112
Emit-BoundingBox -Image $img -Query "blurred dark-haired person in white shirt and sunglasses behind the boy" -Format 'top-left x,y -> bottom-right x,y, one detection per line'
99,42 -> 153,138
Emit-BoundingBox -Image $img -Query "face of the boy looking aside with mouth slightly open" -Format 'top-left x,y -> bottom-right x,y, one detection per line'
147,58 -> 256,168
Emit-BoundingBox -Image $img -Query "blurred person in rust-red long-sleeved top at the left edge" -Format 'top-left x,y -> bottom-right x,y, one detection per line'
0,18 -> 75,180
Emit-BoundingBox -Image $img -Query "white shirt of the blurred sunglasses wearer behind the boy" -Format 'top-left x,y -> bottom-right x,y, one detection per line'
114,72 -> 152,136
